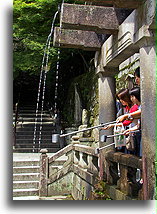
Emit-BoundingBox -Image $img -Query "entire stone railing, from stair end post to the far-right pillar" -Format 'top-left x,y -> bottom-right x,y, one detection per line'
39,136 -> 144,200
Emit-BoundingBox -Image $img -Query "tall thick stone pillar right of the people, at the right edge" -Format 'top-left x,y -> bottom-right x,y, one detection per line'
140,41 -> 156,200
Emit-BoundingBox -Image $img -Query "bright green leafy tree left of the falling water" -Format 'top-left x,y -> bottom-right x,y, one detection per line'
13,0 -> 59,78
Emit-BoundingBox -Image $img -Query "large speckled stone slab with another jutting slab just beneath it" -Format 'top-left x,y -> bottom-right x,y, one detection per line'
61,4 -> 119,34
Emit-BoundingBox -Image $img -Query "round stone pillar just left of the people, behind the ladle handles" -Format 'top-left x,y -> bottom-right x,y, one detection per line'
98,68 -> 118,179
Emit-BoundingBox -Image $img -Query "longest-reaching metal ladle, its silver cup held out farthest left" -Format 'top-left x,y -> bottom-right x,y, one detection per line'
52,121 -> 116,143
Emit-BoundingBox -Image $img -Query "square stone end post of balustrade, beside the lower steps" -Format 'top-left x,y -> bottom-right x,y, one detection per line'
39,149 -> 48,197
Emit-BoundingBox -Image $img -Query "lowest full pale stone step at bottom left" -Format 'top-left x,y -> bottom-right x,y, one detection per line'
13,188 -> 39,197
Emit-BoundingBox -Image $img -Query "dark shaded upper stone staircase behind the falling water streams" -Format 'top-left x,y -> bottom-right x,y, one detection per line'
13,106 -> 64,153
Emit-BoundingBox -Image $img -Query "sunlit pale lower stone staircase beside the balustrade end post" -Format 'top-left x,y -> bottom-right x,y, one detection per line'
13,153 -> 73,200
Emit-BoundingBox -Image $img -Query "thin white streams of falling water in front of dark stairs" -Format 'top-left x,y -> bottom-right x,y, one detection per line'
33,10 -> 60,152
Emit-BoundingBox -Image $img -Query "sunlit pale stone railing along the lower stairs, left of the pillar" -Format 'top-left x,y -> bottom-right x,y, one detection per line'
39,137 -> 99,200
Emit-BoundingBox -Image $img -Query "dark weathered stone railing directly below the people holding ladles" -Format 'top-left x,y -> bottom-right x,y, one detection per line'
105,152 -> 143,200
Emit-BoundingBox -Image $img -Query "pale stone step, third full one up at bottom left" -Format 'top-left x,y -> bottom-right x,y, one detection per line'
13,173 -> 39,181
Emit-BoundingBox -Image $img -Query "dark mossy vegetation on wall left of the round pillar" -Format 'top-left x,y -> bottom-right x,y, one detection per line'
63,68 -> 98,126
